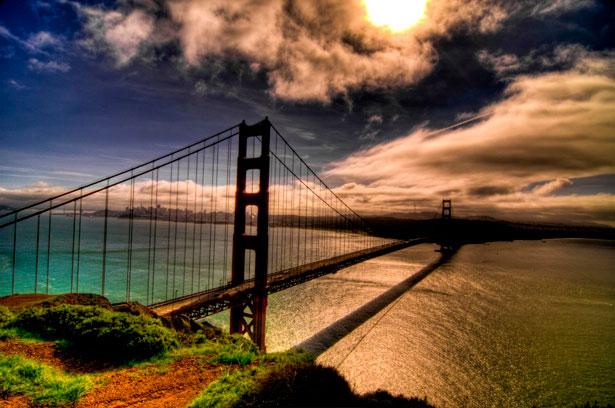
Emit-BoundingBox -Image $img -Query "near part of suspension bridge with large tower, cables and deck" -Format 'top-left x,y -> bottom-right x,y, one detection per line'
0,118 -> 424,349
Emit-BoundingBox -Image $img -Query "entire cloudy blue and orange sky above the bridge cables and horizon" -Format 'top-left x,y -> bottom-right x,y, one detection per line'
0,0 -> 615,225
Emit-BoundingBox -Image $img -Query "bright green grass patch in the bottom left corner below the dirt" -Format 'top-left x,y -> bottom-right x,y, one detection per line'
0,354 -> 91,407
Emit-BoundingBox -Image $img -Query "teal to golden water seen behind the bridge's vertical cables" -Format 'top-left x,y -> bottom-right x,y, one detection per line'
0,218 -> 390,304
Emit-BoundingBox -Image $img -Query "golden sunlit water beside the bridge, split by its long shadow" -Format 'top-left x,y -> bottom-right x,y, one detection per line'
260,240 -> 615,407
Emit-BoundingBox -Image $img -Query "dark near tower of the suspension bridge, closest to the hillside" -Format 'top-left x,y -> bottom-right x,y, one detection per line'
230,118 -> 271,351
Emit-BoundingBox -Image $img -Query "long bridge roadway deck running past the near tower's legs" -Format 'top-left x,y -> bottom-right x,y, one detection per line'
150,238 -> 427,319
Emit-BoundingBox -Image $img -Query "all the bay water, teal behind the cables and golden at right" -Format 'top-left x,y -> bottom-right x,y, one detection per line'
0,216 -> 615,407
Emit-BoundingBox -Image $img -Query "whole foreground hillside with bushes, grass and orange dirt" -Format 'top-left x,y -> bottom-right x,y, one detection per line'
0,295 -> 429,407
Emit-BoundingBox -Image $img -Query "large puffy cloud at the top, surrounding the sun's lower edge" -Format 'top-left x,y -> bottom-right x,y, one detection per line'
80,0 -> 507,103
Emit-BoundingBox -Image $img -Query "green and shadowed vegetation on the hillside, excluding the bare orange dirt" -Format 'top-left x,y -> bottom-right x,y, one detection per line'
0,298 -> 429,407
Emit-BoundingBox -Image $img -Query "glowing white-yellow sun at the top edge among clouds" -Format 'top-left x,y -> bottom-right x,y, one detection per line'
363,0 -> 428,32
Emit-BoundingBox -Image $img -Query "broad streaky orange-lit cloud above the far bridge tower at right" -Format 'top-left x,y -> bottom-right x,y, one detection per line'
326,53 -> 615,225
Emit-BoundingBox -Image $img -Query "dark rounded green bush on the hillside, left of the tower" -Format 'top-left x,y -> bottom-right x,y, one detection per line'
12,305 -> 178,361
